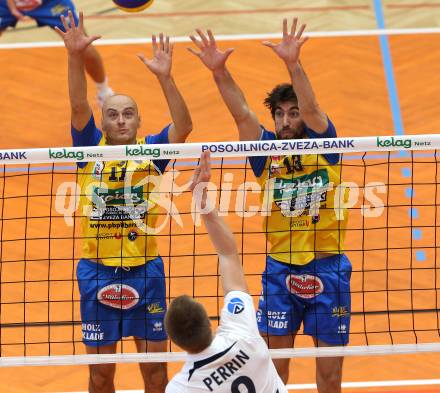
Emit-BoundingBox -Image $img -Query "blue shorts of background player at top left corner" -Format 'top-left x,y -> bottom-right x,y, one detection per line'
0,0 -> 78,31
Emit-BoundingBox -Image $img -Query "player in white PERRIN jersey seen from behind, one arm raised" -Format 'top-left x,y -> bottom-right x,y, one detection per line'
165,152 -> 287,393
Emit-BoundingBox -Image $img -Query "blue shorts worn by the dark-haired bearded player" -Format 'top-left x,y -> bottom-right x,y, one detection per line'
257,254 -> 351,345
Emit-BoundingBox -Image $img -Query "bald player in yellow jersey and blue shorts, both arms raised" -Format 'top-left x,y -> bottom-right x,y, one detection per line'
59,12 -> 192,393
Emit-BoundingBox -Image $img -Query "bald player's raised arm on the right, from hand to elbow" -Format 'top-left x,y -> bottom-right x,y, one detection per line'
138,33 -> 192,143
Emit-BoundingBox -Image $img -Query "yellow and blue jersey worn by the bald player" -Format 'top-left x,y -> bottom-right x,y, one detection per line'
72,116 -> 169,266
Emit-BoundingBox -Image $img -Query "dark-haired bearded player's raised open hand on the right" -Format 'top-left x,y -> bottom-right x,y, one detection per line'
263,18 -> 308,67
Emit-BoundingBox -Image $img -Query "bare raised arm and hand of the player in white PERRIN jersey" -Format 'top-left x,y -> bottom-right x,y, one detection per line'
190,152 -> 248,295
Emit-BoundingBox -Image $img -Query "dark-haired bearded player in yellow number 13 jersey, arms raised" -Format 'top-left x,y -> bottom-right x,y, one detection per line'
191,18 -> 351,393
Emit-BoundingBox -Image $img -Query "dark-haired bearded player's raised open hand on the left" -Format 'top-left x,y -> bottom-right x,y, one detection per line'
188,29 -> 234,71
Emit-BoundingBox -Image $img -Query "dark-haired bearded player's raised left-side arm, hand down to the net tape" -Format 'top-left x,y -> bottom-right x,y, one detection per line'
188,29 -> 261,141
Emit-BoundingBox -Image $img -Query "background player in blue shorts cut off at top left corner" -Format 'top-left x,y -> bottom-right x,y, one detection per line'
0,0 -> 113,107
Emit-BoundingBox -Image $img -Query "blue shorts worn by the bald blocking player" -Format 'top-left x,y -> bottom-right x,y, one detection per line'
76,257 -> 167,346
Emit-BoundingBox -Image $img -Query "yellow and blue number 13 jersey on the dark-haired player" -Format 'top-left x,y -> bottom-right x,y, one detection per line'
249,120 -> 348,265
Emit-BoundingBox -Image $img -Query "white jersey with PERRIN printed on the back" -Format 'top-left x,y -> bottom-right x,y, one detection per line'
166,291 -> 287,393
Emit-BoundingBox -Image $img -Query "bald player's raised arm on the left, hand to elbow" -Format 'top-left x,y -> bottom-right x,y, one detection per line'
55,11 -> 100,131
